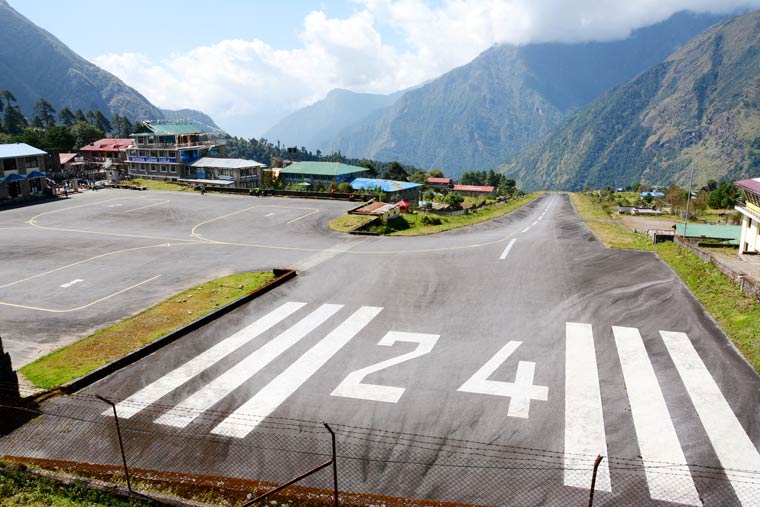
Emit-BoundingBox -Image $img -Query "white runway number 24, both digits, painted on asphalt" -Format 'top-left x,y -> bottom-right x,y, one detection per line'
331,331 -> 549,418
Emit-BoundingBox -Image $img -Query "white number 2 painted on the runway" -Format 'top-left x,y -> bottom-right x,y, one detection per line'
332,331 -> 440,403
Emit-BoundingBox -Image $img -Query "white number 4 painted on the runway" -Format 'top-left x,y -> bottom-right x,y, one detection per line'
457,341 -> 549,419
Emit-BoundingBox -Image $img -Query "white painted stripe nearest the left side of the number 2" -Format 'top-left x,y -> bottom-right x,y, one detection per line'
211,306 -> 383,438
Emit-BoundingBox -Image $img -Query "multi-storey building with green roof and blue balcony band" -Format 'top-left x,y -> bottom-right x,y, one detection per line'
127,121 -> 224,181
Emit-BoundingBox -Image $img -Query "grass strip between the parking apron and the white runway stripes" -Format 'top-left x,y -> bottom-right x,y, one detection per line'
19,272 -> 274,389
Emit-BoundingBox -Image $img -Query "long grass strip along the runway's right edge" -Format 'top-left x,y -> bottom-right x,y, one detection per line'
570,194 -> 760,372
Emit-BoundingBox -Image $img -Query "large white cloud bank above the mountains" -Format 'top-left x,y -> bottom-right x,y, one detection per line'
95,0 -> 760,136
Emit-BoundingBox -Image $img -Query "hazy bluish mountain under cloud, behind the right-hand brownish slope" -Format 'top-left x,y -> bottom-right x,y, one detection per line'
328,13 -> 720,176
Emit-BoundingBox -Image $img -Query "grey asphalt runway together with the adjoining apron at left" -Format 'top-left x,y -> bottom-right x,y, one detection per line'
0,192 -> 760,506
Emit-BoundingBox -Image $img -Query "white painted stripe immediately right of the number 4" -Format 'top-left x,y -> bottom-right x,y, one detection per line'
565,322 -> 612,491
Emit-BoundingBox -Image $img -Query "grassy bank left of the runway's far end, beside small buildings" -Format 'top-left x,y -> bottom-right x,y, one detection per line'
378,192 -> 543,236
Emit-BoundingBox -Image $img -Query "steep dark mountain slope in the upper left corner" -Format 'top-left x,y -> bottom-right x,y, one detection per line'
0,0 -> 218,127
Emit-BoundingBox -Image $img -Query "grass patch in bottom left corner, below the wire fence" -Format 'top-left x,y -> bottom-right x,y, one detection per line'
0,464 -> 162,507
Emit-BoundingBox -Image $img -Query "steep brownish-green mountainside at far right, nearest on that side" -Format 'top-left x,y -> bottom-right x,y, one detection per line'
501,12 -> 760,190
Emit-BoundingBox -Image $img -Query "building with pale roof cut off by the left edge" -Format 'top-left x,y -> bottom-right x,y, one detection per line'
0,143 -> 47,199
